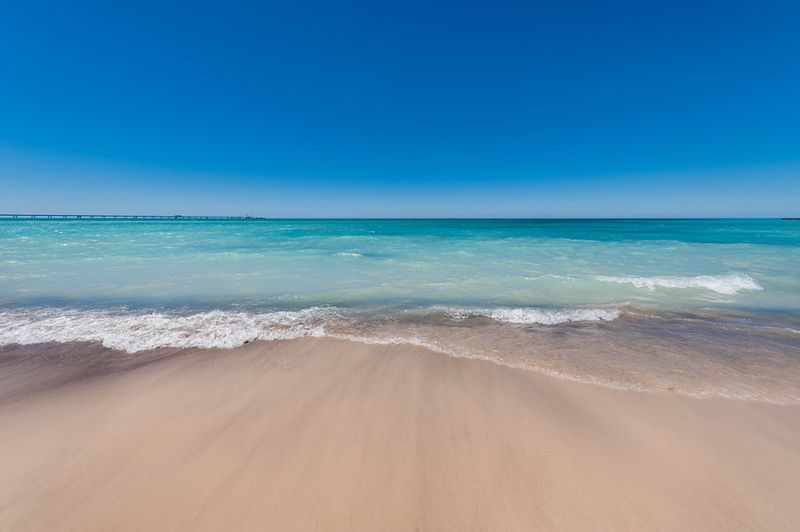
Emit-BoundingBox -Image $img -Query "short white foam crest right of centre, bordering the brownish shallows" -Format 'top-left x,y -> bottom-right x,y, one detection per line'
441,307 -> 620,325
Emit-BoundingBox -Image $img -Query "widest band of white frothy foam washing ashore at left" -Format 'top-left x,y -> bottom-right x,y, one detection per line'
0,307 -> 334,353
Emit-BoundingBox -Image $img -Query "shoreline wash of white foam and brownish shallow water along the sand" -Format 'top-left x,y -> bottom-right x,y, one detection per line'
0,306 -> 800,403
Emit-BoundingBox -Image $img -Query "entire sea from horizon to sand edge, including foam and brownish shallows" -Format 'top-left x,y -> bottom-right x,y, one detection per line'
0,219 -> 800,403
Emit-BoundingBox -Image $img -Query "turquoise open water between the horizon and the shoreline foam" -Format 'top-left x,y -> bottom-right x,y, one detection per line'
0,220 -> 800,310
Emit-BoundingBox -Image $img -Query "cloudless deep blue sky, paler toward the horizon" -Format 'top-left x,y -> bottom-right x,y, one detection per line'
0,0 -> 800,217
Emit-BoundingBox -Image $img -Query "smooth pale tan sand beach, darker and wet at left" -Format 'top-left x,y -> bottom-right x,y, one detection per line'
0,339 -> 800,531
